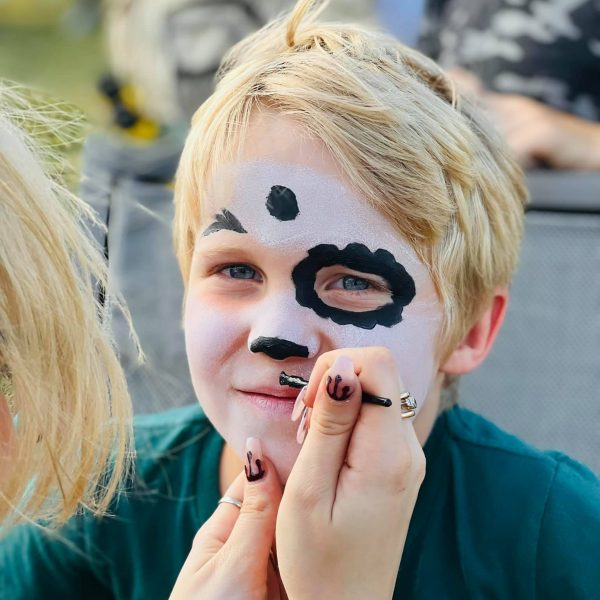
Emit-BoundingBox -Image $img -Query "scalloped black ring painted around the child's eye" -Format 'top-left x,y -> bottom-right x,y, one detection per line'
292,243 -> 416,329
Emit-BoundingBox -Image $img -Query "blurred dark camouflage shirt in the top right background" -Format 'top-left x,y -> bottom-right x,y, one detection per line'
419,0 -> 600,121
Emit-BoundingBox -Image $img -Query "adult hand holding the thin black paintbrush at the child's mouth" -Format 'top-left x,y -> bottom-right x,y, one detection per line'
276,348 -> 425,600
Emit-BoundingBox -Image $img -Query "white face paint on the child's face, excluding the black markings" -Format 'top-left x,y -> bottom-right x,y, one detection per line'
185,124 -> 442,480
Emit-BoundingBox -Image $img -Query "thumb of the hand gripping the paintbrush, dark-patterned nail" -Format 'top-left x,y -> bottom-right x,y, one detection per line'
290,354 -> 362,502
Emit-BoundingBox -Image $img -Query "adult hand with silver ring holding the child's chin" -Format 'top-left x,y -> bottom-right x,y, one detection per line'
170,438 -> 285,600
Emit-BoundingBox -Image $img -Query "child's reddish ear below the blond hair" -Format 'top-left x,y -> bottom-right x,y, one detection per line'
440,288 -> 508,375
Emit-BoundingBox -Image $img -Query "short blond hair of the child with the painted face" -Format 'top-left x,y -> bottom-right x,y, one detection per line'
174,0 -> 527,357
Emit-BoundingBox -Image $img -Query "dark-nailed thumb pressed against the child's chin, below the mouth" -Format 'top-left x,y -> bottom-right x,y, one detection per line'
224,438 -> 282,568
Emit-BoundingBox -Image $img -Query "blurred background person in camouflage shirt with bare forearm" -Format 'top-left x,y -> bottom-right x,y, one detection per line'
419,0 -> 600,170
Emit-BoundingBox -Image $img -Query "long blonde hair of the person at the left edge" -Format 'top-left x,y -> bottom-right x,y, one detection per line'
0,82 -> 137,530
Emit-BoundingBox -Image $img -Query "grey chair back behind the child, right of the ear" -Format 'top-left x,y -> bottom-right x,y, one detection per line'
460,172 -> 600,473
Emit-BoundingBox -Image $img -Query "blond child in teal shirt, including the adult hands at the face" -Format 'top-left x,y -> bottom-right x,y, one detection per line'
0,0 -> 600,599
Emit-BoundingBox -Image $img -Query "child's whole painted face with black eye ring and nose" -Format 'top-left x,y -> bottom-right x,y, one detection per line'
185,112 -> 442,480
